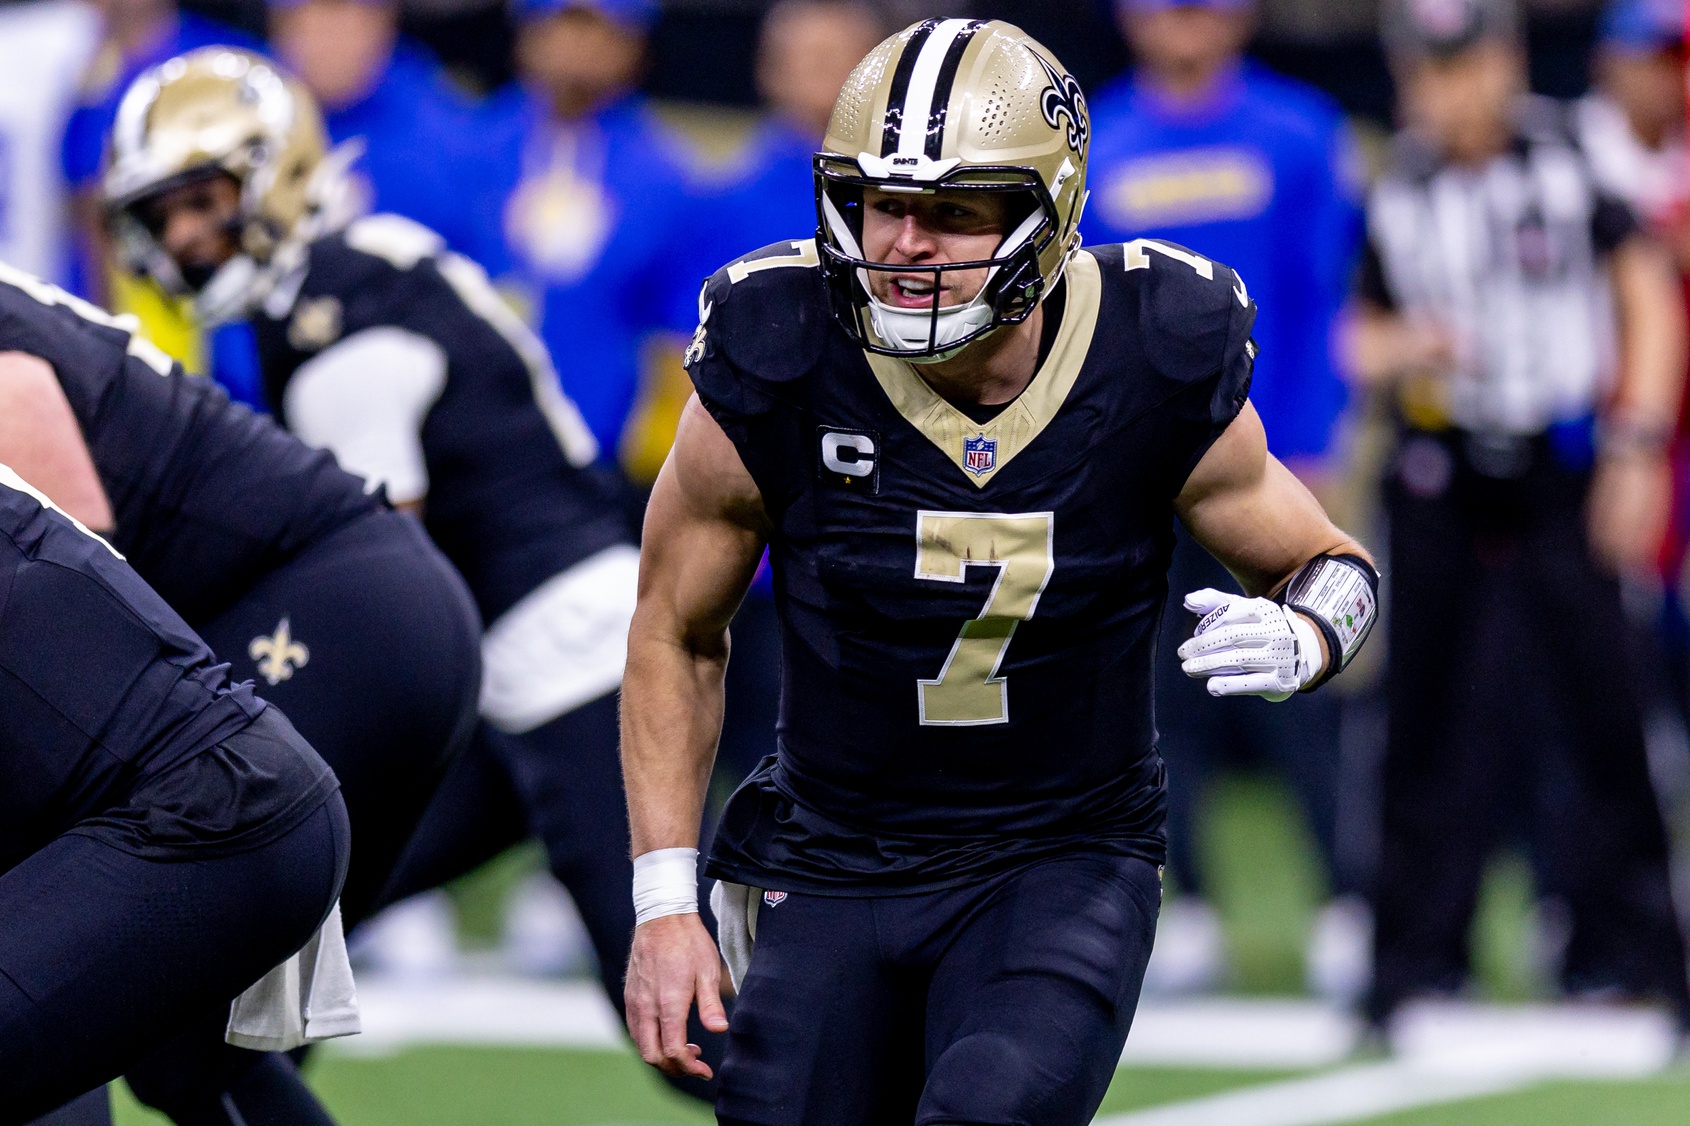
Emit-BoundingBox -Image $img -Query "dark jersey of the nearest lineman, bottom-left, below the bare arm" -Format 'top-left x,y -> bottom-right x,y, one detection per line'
0,470 -> 264,871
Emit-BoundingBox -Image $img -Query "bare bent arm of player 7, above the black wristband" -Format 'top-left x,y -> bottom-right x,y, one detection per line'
1175,402 -> 1372,595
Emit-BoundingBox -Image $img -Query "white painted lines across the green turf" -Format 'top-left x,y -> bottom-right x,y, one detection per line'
333,976 -> 1675,1126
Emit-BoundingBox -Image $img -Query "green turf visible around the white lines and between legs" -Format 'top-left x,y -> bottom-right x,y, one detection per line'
98,778 -> 1690,1126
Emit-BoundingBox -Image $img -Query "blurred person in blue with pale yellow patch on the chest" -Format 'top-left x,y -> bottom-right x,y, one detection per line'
473,0 -> 699,450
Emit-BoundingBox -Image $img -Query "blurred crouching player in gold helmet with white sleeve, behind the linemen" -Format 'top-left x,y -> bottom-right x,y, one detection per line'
106,47 -> 719,1087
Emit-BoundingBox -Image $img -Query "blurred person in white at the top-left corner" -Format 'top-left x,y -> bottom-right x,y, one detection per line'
0,0 -> 100,282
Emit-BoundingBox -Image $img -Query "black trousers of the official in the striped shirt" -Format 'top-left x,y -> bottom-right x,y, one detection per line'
1369,435 -> 1690,1021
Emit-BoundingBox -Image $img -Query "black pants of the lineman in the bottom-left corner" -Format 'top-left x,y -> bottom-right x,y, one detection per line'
0,781 -> 350,1123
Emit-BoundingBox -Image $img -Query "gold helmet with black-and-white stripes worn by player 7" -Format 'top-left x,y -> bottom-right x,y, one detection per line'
815,19 -> 1092,362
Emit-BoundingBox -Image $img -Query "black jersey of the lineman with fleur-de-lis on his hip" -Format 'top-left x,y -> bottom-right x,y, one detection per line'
0,267 -> 380,624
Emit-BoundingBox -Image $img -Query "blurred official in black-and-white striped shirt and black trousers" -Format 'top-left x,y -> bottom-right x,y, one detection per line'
1354,0 -> 1690,1023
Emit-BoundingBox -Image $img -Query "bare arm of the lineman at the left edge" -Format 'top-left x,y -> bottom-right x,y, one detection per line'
0,352 -> 115,533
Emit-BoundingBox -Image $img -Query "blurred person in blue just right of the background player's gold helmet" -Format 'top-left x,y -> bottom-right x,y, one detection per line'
270,0 -> 475,254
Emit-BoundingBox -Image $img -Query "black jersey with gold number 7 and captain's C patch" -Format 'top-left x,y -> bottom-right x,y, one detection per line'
688,242 -> 1256,894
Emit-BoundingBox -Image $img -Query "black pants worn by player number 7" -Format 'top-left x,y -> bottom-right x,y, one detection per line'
717,852 -> 1161,1126
